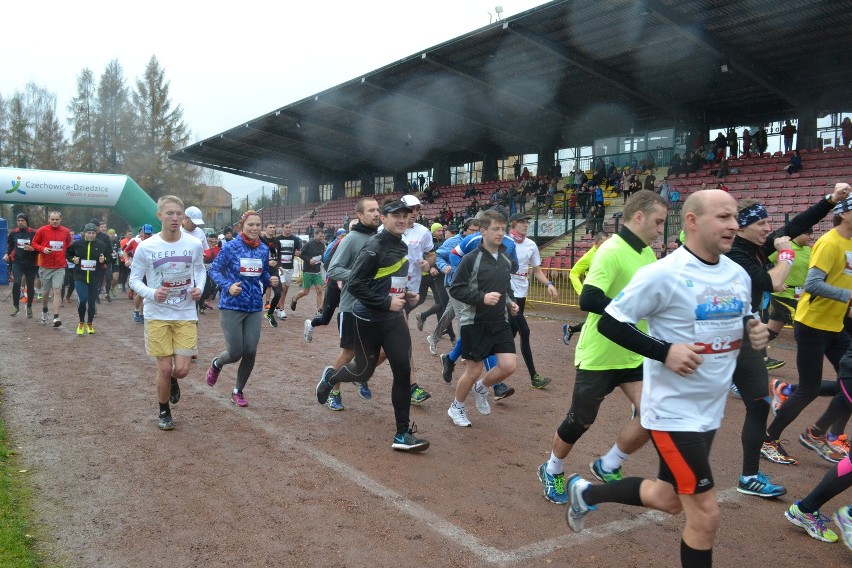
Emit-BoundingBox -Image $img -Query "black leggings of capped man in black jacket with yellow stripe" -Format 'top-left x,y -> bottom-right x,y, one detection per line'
329,314 -> 411,434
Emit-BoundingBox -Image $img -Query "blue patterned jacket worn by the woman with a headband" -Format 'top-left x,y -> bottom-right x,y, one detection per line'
208,236 -> 269,312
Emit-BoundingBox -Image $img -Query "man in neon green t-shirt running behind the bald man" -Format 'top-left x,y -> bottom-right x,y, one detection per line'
538,190 -> 668,504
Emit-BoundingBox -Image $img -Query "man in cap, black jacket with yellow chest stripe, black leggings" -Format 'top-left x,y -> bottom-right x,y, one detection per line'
316,200 -> 429,451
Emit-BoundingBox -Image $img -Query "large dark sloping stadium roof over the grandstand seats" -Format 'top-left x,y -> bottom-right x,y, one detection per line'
171,0 -> 852,185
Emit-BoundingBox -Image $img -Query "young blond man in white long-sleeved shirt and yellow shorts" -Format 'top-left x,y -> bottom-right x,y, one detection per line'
130,195 -> 207,430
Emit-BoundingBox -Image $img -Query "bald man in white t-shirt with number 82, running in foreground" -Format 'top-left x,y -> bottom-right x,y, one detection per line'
566,190 -> 769,568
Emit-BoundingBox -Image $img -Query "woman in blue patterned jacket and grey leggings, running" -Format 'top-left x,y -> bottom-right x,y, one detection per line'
207,211 -> 278,406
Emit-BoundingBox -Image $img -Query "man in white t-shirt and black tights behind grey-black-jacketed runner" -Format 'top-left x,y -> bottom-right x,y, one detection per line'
509,213 -> 559,389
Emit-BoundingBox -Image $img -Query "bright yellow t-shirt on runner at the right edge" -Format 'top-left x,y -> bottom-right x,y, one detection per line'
795,229 -> 852,332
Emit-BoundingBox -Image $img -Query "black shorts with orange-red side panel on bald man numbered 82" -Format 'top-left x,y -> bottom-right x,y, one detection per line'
648,430 -> 716,495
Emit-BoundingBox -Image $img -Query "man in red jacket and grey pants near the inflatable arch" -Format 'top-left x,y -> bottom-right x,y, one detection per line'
32,211 -> 72,327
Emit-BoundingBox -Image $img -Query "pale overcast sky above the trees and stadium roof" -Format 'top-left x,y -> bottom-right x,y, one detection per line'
8,0 -> 544,197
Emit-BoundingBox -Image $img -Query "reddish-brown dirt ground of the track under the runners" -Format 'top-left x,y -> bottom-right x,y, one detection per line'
0,287 -> 852,568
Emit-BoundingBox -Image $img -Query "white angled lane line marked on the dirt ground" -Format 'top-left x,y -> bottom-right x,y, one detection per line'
203,385 -> 739,565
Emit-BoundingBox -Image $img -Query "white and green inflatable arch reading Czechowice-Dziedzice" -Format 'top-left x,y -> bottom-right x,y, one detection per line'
0,168 -> 160,231
